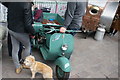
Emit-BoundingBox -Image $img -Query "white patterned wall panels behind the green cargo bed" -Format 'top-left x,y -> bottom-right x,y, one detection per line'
34,0 -> 67,16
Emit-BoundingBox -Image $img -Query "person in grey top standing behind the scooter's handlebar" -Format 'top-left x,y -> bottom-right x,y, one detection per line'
64,0 -> 87,35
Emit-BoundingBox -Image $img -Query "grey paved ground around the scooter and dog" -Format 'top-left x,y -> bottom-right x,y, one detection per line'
0,22 -> 118,78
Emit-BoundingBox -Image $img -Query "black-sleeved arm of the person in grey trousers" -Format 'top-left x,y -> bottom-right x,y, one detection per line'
24,3 -> 35,34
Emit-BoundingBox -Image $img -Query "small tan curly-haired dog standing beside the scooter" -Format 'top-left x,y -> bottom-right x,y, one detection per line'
24,55 -> 53,79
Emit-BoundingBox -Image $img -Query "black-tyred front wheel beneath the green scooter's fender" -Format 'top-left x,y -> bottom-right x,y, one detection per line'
56,66 -> 70,80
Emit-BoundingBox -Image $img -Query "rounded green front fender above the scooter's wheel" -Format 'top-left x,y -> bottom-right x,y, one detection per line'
55,56 -> 71,72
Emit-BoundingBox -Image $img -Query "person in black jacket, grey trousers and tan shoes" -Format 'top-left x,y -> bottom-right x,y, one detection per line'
1,2 -> 35,73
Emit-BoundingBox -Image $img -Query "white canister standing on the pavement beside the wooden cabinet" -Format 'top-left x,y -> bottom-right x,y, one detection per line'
94,27 -> 105,41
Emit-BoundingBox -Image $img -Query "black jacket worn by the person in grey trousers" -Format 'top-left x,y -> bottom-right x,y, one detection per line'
3,2 -> 35,34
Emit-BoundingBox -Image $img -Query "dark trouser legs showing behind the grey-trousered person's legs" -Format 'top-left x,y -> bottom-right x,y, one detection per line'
7,33 -> 23,60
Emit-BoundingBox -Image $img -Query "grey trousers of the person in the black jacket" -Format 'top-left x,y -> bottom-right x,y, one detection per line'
9,30 -> 31,68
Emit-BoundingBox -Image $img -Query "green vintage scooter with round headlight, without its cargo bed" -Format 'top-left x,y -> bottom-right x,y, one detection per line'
31,12 -> 80,80
